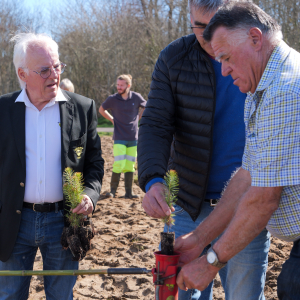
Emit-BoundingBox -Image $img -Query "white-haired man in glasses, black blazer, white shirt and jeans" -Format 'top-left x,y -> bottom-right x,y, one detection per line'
0,33 -> 104,300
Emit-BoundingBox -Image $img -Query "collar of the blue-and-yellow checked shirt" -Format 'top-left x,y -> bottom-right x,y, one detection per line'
255,41 -> 291,92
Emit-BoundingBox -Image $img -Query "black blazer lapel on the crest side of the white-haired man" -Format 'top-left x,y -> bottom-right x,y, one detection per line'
59,93 -> 74,172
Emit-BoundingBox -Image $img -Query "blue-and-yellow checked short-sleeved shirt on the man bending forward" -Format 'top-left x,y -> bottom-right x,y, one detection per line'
243,41 -> 300,241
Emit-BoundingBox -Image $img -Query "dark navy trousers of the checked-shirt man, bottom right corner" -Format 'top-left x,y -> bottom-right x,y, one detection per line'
277,240 -> 300,300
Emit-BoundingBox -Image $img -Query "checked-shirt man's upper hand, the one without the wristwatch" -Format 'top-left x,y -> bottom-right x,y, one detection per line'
174,230 -> 205,265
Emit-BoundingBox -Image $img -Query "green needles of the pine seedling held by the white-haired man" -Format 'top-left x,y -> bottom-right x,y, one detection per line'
63,168 -> 84,227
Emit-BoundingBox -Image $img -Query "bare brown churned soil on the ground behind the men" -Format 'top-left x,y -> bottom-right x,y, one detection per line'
29,136 -> 292,300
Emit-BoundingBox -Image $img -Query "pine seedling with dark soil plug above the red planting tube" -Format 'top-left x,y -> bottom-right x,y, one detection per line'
161,170 -> 179,255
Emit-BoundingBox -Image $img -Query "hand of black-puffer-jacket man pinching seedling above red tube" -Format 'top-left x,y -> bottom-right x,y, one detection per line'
142,182 -> 175,218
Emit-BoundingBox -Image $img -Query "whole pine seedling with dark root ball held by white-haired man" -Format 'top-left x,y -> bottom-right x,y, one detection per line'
61,168 -> 94,261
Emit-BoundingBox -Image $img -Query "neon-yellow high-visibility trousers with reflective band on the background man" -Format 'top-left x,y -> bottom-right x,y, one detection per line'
113,140 -> 137,173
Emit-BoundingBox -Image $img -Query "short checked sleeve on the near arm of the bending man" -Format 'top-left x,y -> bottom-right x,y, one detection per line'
250,93 -> 300,187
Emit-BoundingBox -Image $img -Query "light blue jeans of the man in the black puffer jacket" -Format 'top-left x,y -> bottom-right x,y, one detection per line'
165,202 -> 270,300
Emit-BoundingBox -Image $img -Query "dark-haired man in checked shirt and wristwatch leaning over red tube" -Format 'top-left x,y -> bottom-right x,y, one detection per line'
175,2 -> 300,300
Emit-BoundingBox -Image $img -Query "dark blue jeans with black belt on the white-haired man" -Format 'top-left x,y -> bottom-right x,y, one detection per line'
0,208 -> 78,300
